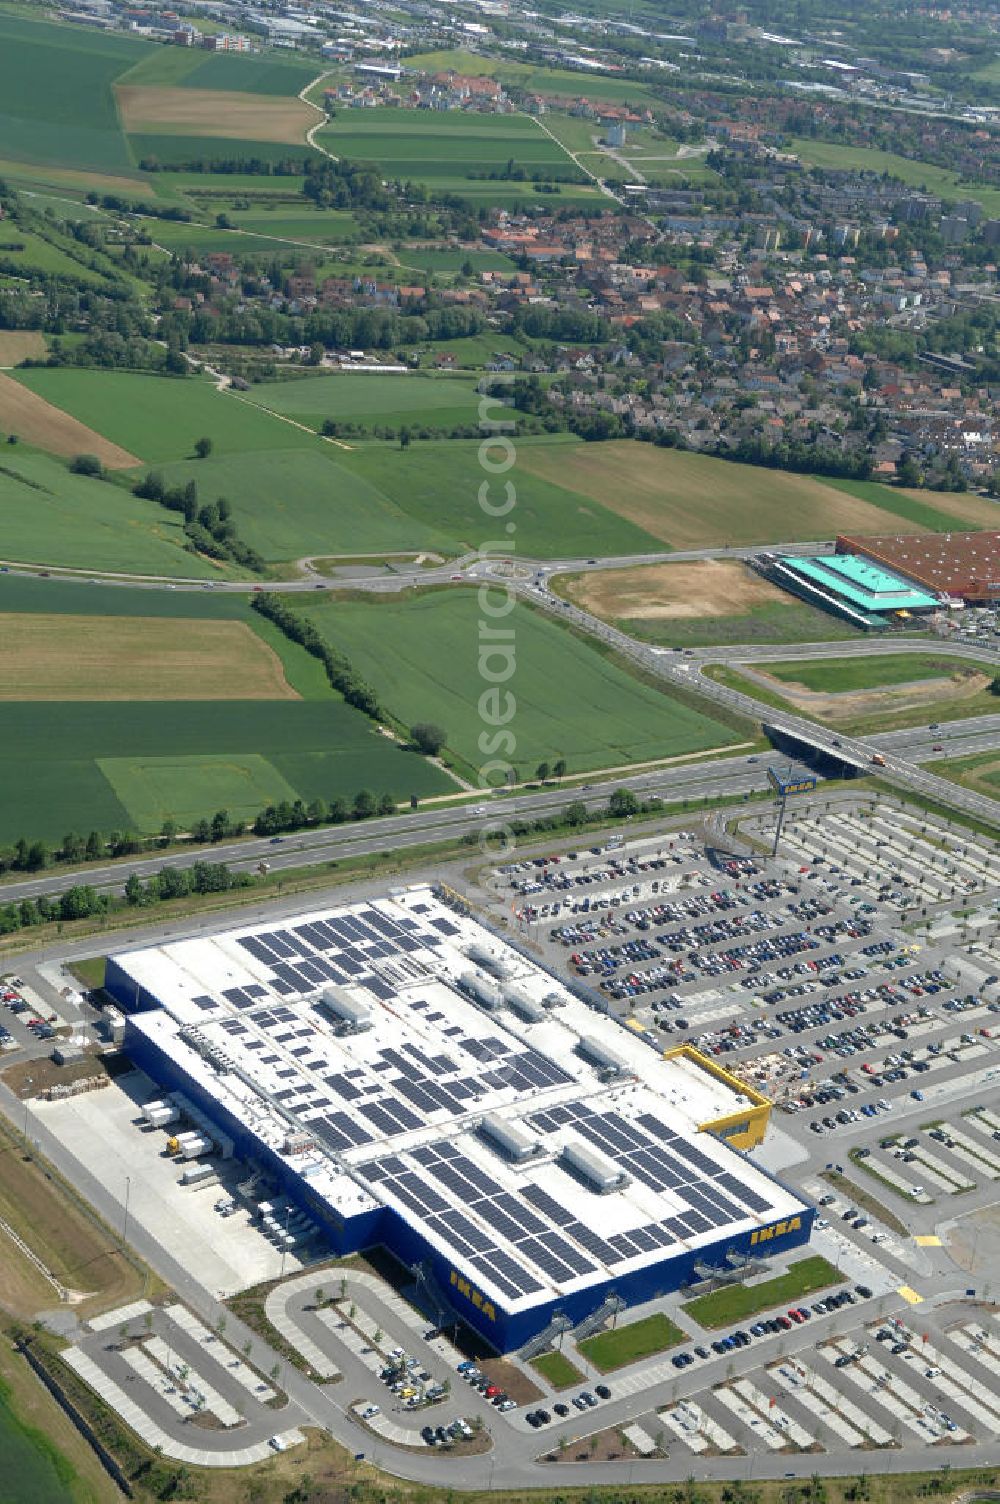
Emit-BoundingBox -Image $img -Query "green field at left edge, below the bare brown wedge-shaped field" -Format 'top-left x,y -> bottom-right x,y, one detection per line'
0,445 -> 224,579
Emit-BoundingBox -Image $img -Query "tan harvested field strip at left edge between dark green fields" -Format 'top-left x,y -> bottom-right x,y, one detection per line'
0,614 -> 298,701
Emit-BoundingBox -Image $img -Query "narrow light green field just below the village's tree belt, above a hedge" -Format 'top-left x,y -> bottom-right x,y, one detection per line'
245,373 -> 496,429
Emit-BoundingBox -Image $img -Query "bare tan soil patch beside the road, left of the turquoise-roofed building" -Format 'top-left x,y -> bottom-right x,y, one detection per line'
565,559 -> 789,621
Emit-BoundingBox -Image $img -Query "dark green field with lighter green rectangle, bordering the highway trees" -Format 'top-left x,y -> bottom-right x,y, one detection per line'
0,695 -> 454,841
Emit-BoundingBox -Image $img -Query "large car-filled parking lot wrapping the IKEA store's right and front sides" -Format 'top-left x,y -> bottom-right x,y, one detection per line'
475,796 -> 1000,1456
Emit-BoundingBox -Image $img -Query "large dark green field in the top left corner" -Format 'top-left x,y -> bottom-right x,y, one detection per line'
0,15 -> 151,171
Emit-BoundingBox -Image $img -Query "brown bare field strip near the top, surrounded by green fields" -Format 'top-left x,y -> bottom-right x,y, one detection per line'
116,84 -> 320,146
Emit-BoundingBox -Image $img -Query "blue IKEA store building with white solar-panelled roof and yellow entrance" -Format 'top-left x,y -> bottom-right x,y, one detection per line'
105,886 -> 815,1352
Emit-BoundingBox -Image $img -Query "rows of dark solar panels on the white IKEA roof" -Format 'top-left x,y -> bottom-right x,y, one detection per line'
130,902 -> 793,1302
